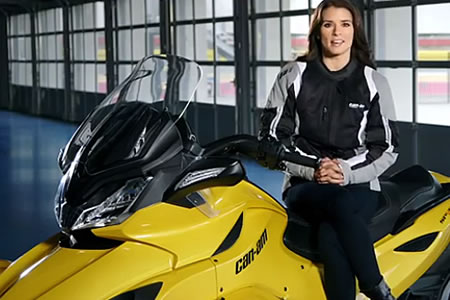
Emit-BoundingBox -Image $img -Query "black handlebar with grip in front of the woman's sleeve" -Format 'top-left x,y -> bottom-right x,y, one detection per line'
203,134 -> 318,168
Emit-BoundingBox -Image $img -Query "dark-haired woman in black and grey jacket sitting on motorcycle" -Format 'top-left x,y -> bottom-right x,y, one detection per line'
260,0 -> 398,300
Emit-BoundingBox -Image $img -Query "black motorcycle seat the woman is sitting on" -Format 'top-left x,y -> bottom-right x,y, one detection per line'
284,165 -> 450,261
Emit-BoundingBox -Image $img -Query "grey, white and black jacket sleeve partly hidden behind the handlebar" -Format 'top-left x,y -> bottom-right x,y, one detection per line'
258,62 -> 314,180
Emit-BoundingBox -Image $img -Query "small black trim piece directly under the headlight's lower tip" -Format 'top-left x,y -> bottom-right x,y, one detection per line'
59,229 -> 123,250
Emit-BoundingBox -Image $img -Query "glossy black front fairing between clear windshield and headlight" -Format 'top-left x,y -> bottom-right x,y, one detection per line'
62,102 -> 187,228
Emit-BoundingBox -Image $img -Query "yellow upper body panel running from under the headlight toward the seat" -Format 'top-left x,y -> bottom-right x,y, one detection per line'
94,182 -> 283,268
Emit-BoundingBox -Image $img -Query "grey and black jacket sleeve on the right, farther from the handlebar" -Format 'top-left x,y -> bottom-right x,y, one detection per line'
340,67 -> 399,185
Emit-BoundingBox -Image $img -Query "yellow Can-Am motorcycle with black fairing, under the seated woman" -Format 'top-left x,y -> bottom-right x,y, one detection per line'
0,56 -> 450,300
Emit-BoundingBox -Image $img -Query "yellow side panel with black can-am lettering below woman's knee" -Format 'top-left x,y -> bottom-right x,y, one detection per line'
213,209 -> 326,300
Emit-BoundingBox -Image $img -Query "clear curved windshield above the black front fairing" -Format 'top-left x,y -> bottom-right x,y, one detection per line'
59,55 -> 202,172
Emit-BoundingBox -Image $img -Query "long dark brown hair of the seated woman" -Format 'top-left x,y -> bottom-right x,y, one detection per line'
297,0 -> 375,68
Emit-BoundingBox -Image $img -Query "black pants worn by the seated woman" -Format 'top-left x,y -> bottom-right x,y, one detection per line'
286,182 -> 382,300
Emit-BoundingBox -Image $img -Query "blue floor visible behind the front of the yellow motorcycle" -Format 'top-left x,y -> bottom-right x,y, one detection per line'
0,111 -> 283,260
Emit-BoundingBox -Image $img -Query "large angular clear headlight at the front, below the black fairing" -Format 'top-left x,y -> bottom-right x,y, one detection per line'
71,177 -> 153,230
